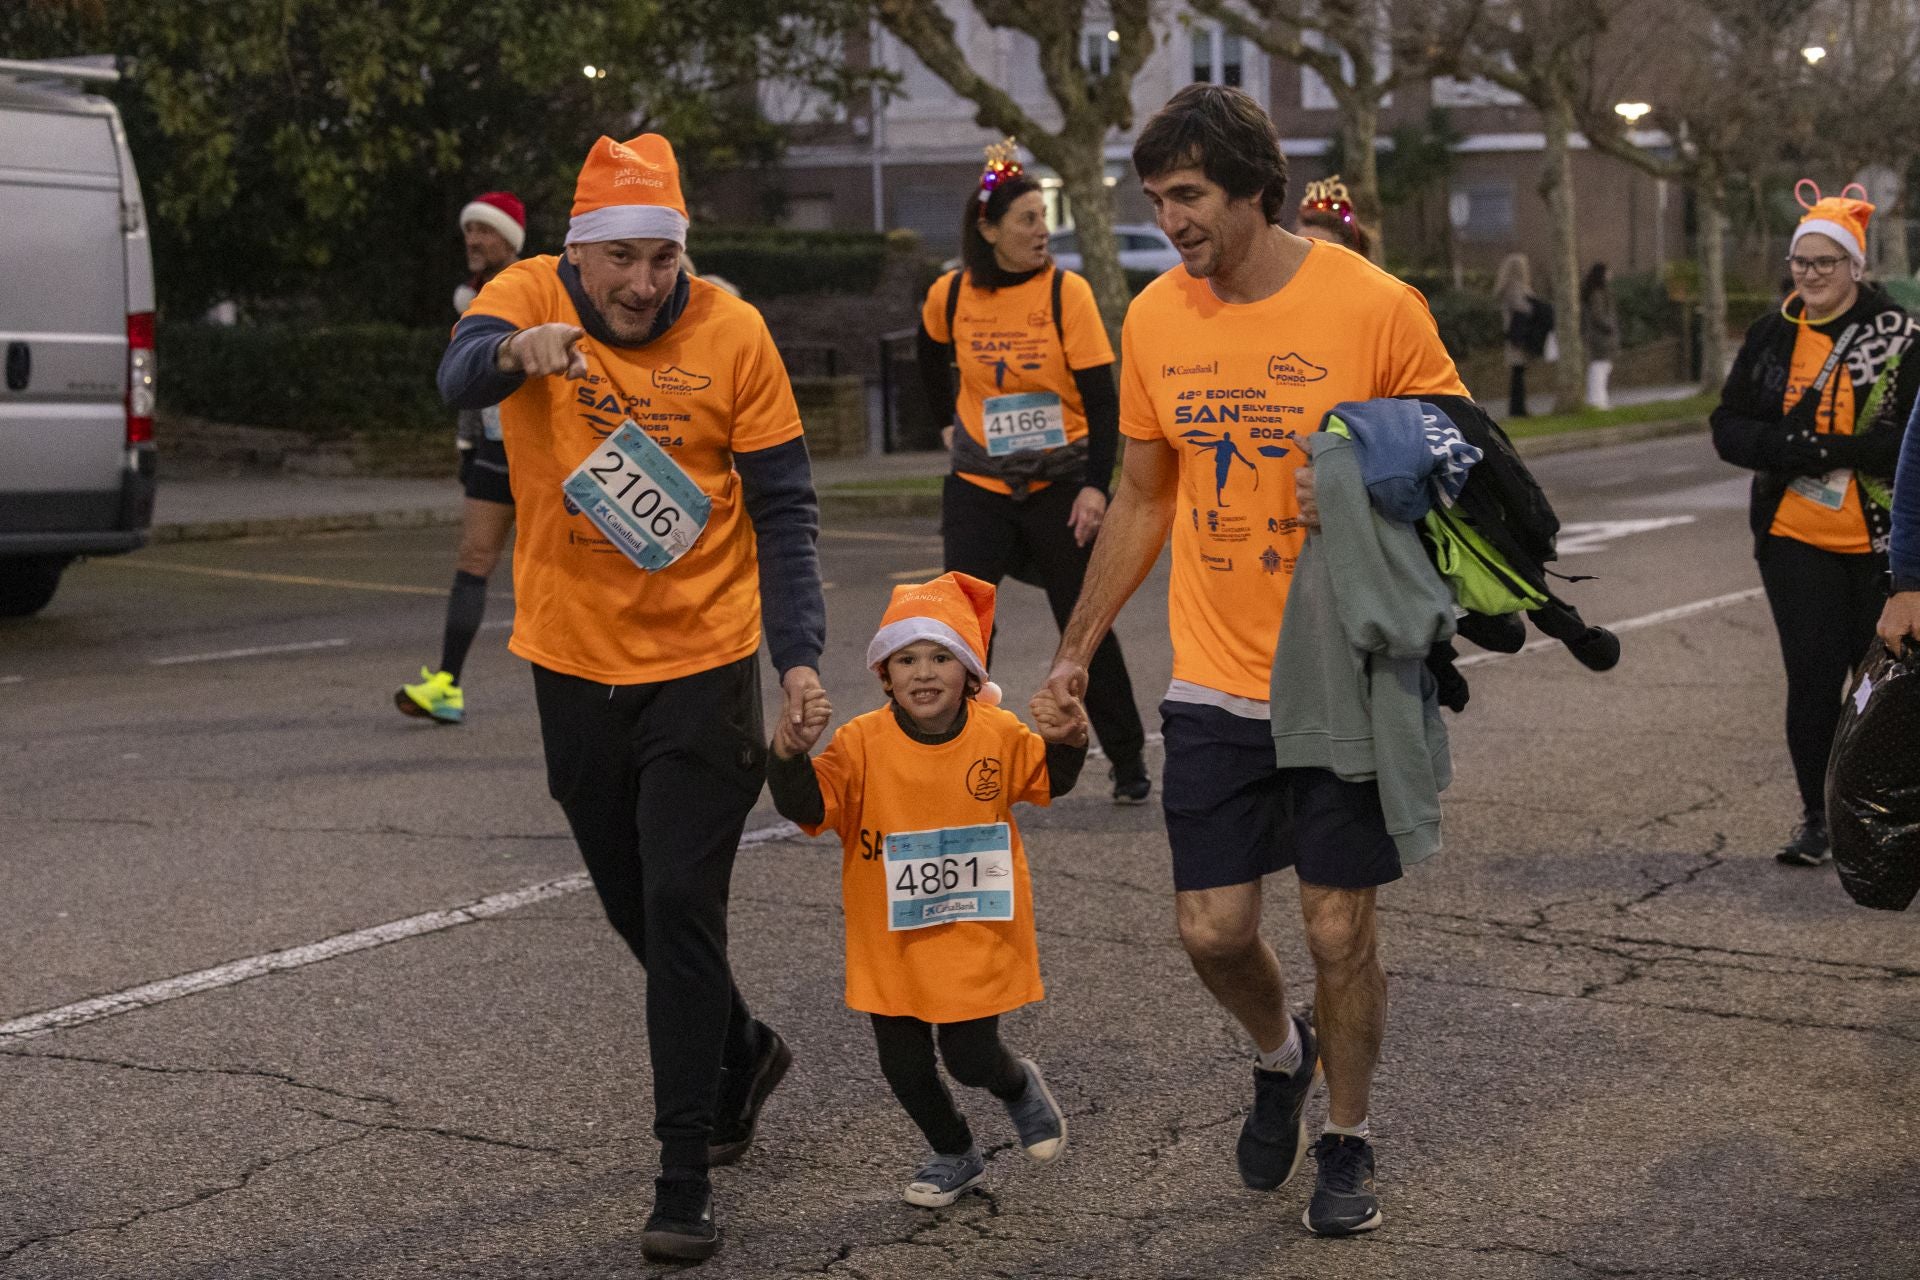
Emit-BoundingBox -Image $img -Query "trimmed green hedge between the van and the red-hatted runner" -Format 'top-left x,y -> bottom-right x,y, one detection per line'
156,324 -> 453,436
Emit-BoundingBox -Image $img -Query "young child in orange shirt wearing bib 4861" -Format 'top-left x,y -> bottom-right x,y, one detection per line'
768,574 -> 1087,1209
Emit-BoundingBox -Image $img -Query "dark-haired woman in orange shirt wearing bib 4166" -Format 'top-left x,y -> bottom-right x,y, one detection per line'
918,138 -> 1154,804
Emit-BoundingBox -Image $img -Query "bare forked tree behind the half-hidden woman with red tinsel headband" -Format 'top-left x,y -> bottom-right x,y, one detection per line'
1187,0 -> 1484,261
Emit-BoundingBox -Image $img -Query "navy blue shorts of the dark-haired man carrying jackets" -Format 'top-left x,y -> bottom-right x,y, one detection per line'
1160,702 -> 1400,890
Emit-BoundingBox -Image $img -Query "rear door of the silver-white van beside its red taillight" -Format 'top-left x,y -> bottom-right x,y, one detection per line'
0,104 -> 129,533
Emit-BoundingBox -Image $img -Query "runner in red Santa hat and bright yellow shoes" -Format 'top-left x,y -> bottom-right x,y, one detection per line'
394,192 -> 526,723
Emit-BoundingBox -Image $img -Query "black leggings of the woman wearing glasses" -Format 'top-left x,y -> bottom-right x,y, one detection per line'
1759,535 -> 1887,814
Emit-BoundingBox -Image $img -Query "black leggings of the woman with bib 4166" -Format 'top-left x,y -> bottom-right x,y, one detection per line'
941,476 -> 1146,766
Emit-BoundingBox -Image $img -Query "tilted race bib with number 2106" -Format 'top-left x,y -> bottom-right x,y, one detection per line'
563,418 -> 712,570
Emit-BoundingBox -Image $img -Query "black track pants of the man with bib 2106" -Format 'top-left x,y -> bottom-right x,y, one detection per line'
534,658 -> 766,1169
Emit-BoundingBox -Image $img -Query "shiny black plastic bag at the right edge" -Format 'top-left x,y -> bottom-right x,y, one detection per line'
1826,641 -> 1920,912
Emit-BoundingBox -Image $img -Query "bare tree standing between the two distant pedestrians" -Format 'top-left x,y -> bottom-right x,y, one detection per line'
1457,0 -> 1622,411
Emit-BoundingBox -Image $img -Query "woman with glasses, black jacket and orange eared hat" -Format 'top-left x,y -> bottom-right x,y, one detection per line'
1713,180 -> 1920,867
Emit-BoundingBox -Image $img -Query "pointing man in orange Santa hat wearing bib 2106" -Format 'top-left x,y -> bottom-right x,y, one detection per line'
440,134 -> 826,1261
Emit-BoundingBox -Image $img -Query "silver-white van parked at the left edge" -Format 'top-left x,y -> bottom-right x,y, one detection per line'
0,59 -> 154,616
